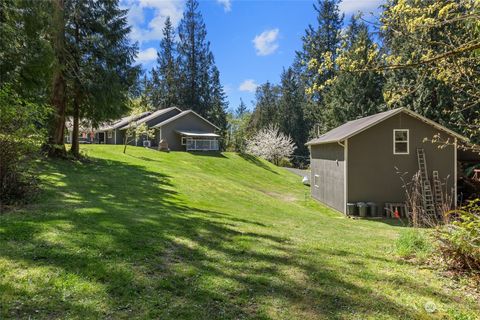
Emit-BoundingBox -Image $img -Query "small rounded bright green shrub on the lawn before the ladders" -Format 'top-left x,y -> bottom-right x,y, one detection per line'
395,229 -> 432,261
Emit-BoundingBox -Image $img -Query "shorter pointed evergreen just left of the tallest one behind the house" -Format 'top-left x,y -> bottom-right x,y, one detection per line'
149,17 -> 181,109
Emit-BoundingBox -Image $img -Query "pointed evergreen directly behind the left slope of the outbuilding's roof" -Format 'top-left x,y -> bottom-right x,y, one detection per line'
322,17 -> 385,131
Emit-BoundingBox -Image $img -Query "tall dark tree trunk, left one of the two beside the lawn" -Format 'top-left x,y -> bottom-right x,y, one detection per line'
46,0 -> 67,157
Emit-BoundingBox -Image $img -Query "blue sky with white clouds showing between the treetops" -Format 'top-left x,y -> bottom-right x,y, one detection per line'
121,0 -> 383,109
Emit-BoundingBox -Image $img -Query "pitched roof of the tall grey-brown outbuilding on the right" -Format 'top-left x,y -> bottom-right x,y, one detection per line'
306,108 -> 468,145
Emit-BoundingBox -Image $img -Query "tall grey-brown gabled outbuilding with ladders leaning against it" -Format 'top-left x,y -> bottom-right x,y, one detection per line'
307,108 -> 467,213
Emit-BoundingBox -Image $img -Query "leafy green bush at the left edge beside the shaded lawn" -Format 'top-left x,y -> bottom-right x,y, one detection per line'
0,86 -> 48,210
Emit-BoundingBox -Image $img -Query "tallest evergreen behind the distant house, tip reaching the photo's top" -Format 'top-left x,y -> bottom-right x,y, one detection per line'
178,0 -> 213,116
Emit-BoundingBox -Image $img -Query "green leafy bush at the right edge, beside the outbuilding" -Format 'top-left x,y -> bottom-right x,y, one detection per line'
437,199 -> 480,272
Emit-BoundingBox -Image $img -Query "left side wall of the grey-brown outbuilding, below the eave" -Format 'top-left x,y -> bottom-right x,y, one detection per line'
310,143 -> 345,212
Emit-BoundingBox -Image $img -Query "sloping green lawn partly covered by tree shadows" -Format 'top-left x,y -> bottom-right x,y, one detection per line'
0,145 -> 479,319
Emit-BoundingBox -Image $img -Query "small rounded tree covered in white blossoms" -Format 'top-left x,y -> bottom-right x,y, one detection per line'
246,126 -> 297,165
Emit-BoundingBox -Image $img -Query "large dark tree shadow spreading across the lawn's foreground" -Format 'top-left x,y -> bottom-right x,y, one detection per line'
0,156 -> 468,319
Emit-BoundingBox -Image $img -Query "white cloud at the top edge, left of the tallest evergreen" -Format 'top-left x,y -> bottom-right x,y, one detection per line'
121,0 -> 184,43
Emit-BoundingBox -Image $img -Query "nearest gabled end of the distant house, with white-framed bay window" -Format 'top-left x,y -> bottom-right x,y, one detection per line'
152,110 -> 220,151
